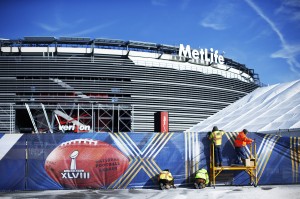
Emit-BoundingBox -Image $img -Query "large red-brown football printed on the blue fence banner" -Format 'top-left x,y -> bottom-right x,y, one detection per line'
45,139 -> 129,189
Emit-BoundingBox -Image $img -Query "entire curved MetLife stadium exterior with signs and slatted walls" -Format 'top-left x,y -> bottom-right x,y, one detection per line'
0,37 -> 260,133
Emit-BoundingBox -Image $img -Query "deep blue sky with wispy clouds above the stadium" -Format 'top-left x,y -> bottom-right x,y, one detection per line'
0,0 -> 300,85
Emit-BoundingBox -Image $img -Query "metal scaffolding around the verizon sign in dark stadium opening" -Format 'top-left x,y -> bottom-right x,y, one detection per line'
21,103 -> 133,133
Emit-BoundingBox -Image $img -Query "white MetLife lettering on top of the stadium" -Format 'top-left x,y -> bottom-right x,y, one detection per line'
178,44 -> 224,64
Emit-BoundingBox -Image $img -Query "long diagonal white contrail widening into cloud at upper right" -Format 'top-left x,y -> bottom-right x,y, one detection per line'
245,0 -> 300,77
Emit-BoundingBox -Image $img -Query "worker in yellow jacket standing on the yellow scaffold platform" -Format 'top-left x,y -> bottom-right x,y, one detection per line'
209,126 -> 224,167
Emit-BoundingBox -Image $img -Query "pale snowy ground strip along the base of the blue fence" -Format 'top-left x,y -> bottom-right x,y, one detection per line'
0,185 -> 300,199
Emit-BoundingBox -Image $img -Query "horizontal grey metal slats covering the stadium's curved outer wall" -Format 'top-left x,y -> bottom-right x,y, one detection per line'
0,49 -> 257,131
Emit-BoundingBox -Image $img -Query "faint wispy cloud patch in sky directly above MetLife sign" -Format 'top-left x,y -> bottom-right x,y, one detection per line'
200,3 -> 234,30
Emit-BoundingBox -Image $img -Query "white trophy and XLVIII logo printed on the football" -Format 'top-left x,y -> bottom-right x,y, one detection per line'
61,151 -> 90,179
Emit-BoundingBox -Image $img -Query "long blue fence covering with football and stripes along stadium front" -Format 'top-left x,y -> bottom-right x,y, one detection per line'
0,132 -> 300,190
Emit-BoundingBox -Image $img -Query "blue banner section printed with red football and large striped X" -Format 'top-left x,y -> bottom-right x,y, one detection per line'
28,133 -> 184,190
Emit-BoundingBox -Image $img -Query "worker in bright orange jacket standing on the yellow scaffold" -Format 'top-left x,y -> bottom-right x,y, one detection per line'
234,129 -> 253,164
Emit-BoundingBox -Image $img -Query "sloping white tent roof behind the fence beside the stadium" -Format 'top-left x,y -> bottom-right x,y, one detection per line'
186,80 -> 300,132
